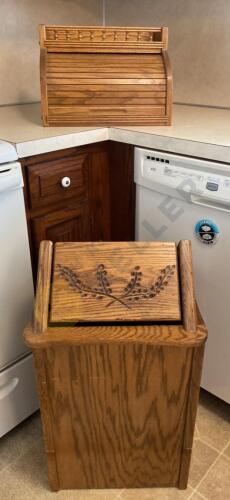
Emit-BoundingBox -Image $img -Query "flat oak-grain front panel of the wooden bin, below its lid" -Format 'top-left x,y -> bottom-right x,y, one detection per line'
46,343 -> 192,488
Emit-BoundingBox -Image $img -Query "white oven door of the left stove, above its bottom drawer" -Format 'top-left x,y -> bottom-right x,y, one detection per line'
0,189 -> 34,370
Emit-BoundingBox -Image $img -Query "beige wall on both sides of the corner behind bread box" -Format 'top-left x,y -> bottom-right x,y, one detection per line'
0,0 -> 230,107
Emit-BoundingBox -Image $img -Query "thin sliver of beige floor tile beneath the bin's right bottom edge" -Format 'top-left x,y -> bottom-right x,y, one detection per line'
121,487 -> 192,500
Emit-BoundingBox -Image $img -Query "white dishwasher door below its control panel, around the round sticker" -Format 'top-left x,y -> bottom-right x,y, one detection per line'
136,186 -> 230,403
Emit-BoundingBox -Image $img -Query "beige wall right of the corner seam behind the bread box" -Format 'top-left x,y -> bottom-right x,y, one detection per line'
106,0 -> 230,107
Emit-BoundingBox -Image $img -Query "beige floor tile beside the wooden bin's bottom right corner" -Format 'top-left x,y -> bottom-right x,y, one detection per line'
188,439 -> 218,488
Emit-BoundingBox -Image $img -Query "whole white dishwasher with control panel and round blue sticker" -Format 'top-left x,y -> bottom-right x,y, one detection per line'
134,148 -> 230,403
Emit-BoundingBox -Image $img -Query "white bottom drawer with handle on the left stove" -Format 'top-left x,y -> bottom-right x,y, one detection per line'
0,354 -> 39,437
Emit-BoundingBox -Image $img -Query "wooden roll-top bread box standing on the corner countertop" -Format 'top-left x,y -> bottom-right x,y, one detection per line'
40,26 -> 172,125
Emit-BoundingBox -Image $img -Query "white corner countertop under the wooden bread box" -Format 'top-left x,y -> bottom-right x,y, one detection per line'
0,104 -> 230,163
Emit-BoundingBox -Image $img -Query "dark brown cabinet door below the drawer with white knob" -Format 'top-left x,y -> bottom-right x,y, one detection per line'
31,204 -> 90,256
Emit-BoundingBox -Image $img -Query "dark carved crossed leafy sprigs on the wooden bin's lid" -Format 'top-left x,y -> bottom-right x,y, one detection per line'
57,264 -> 175,309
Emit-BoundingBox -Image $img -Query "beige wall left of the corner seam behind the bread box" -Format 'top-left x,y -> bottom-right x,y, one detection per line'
0,0 -> 102,104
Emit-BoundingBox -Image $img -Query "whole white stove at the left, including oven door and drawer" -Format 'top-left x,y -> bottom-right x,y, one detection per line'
0,141 -> 38,437
